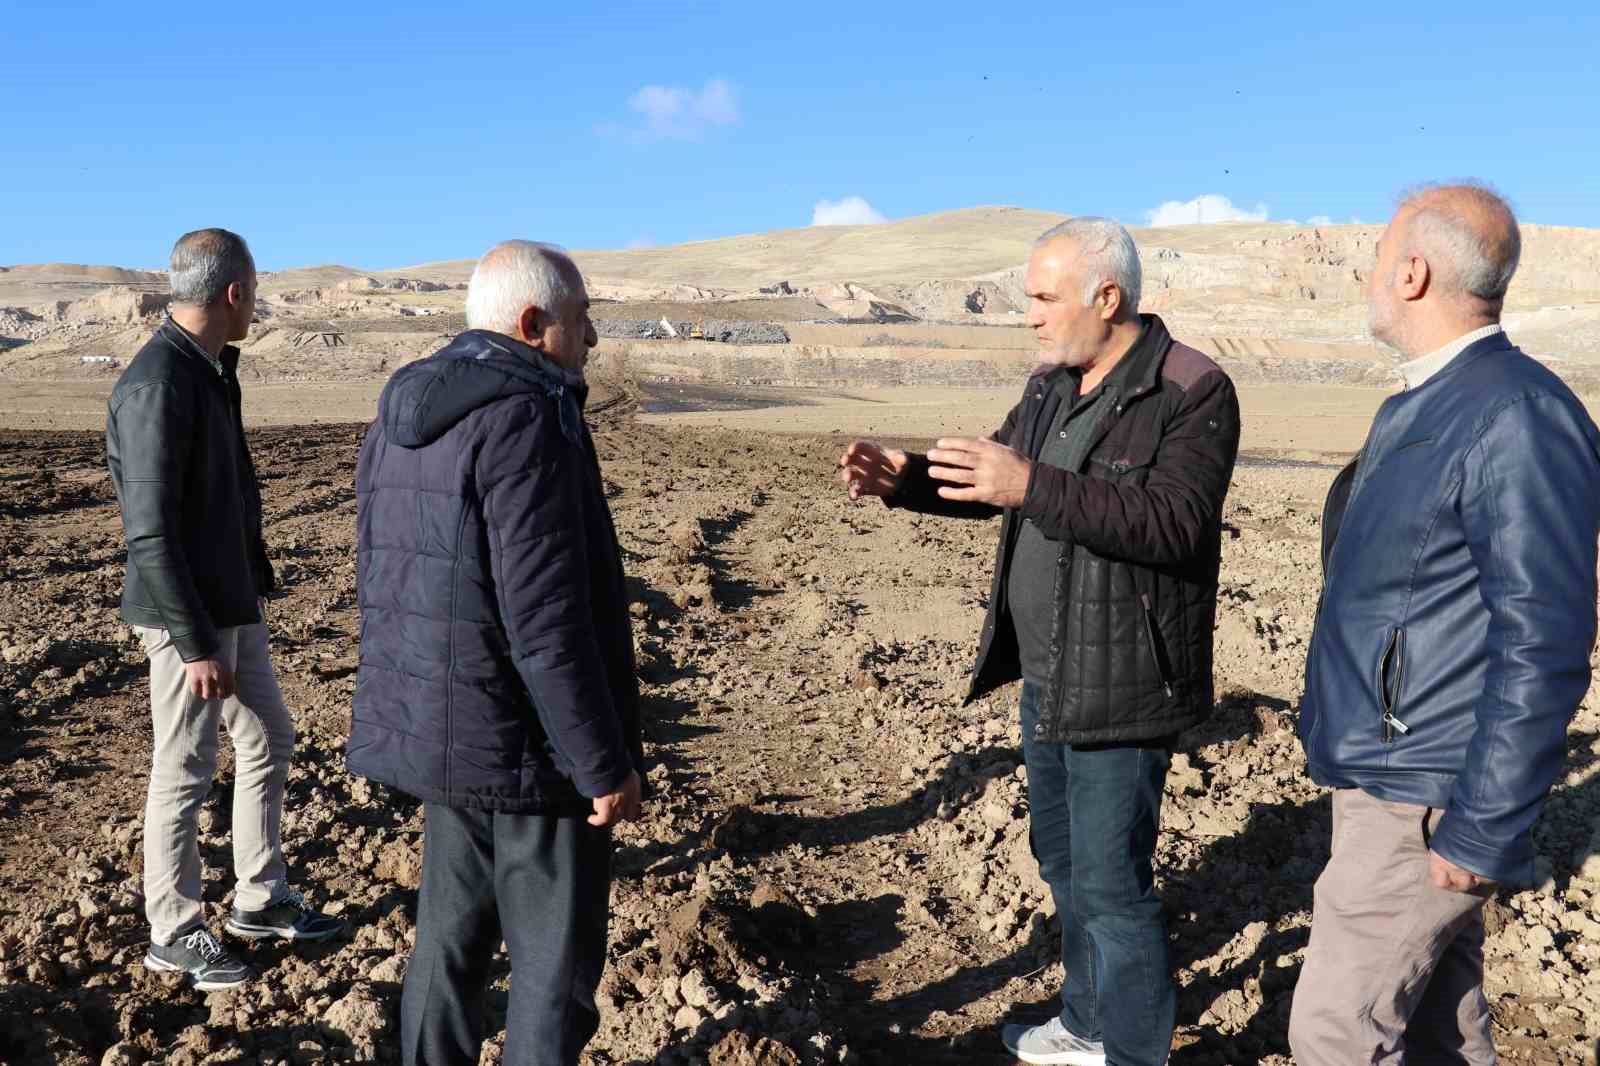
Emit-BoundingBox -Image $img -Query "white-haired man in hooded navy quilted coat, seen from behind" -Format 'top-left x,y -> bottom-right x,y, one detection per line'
349,240 -> 643,1066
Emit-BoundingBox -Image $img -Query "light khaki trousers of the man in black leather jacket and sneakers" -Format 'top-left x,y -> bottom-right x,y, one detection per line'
134,624 -> 294,944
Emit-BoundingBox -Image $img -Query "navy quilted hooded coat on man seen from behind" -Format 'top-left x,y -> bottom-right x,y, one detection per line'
349,330 -> 643,815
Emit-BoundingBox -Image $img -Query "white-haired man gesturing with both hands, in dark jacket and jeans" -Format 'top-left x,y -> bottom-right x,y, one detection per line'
840,218 -> 1238,1066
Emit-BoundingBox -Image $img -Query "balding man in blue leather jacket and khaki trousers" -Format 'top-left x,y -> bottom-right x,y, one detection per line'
1290,186 -> 1600,1066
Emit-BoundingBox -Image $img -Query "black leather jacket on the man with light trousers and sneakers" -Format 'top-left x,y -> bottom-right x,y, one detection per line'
106,319 -> 272,663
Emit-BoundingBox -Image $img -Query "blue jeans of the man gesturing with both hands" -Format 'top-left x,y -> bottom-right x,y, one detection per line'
1021,682 -> 1178,1066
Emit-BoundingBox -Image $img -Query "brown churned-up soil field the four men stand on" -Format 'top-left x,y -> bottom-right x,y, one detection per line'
0,416 -> 1600,1066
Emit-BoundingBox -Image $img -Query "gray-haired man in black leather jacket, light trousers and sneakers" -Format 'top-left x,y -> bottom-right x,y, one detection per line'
106,229 -> 344,991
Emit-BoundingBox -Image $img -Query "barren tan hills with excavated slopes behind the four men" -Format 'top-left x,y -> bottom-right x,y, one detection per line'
9,206 -> 1600,391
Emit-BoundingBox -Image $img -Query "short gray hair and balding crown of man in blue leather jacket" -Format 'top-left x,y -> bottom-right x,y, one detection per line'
1400,181 -> 1522,304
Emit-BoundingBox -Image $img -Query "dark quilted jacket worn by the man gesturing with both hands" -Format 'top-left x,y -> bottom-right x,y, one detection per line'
886,315 -> 1238,744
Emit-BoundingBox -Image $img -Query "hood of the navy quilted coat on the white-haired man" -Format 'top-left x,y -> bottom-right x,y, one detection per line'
378,330 -> 587,448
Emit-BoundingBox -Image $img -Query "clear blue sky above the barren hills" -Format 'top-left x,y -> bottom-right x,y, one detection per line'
0,0 -> 1600,269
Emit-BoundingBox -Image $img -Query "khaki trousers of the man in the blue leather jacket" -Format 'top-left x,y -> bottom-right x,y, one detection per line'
1290,789 -> 1496,1066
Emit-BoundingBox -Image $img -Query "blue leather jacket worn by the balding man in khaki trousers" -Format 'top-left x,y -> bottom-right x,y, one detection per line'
1299,335 -> 1600,882
